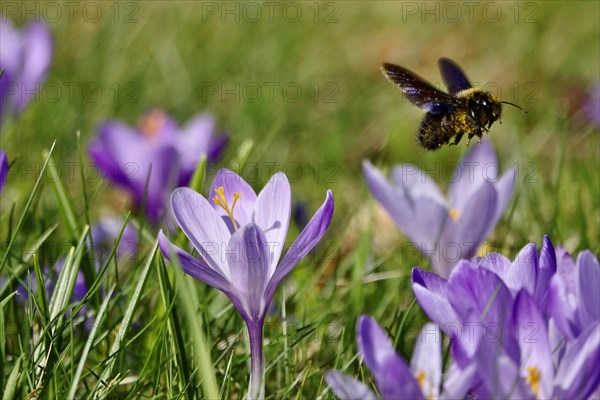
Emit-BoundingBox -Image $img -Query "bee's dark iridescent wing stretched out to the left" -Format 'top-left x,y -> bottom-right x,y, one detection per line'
381,63 -> 456,114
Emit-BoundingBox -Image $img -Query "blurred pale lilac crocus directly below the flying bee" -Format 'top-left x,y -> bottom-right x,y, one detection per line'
363,140 -> 515,277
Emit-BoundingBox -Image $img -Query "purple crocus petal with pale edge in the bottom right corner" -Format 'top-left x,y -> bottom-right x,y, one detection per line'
553,323 -> 600,399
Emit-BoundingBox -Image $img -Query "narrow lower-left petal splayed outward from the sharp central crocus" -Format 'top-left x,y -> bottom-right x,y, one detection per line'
158,231 -> 231,292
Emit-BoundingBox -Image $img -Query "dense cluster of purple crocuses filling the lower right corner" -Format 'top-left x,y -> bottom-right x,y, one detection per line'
413,237 -> 600,399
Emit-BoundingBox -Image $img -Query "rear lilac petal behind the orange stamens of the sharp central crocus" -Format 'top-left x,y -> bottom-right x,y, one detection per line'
209,168 -> 257,228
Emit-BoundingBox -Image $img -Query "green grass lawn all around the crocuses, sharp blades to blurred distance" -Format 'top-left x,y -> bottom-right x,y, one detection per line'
0,1 -> 600,399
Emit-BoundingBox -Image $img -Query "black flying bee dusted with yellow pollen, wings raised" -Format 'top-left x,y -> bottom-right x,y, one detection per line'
381,58 -> 523,150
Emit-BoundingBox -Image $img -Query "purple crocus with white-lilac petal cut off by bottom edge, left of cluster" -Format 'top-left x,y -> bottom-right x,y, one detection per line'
325,315 -> 466,400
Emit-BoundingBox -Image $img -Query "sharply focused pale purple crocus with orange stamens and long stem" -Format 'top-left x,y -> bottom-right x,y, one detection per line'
158,169 -> 334,399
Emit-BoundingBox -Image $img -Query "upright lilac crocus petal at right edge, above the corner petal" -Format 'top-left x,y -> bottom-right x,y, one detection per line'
577,250 -> 600,327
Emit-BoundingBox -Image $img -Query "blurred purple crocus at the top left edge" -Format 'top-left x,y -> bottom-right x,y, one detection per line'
0,17 -> 52,126
